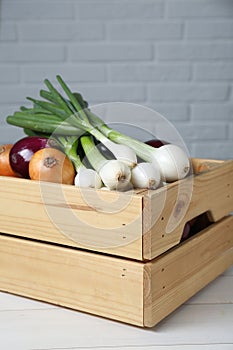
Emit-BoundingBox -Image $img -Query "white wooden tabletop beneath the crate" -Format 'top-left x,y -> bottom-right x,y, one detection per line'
0,266 -> 233,350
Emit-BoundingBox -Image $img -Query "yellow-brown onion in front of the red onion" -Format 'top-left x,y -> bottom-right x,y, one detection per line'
29,148 -> 75,185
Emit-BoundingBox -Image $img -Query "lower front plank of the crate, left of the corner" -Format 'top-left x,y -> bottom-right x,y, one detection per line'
0,235 -> 143,326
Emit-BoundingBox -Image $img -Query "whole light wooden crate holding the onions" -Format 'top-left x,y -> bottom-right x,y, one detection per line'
0,159 -> 233,327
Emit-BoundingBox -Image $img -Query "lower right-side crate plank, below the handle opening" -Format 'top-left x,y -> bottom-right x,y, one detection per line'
144,216 -> 233,327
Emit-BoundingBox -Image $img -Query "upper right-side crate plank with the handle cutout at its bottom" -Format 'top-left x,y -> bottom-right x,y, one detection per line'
143,160 -> 233,260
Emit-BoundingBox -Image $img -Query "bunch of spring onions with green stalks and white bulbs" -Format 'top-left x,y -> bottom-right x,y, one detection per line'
7,76 -> 190,190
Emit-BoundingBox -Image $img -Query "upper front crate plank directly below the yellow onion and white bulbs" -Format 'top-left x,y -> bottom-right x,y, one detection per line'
0,176 -> 142,260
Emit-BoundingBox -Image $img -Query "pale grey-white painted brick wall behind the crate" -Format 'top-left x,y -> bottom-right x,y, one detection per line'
0,0 -> 233,158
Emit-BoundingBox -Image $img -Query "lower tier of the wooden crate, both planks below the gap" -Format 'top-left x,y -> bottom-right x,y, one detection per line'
0,216 -> 233,327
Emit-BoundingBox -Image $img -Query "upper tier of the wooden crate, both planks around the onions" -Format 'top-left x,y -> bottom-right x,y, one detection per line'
0,159 -> 233,261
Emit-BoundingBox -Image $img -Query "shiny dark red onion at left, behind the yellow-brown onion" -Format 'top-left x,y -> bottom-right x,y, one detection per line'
10,136 -> 56,179
